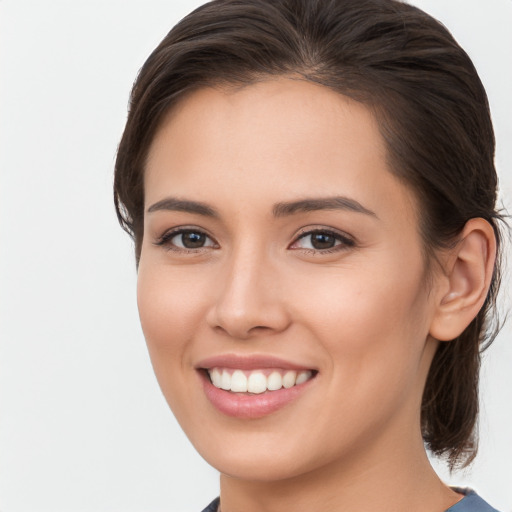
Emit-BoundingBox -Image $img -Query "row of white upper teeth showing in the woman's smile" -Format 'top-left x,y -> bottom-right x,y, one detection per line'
208,368 -> 313,394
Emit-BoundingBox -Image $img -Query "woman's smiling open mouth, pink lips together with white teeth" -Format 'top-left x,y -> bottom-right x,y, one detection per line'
196,355 -> 318,419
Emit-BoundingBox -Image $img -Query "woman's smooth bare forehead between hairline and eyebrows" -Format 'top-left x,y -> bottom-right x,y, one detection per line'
145,78 -> 414,222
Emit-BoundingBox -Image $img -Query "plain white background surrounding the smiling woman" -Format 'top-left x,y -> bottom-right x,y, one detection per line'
0,0 -> 512,512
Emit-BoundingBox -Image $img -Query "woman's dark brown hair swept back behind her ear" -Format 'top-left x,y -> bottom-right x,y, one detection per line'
114,0 -> 501,468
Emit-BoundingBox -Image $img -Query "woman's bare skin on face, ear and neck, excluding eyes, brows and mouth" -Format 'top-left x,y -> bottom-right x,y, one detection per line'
138,78 -> 493,512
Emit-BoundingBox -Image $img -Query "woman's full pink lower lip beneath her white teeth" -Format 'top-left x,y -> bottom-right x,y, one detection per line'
200,371 -> 314,419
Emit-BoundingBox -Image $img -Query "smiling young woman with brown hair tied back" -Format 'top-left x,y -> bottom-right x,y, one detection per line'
115,0 -> 500,512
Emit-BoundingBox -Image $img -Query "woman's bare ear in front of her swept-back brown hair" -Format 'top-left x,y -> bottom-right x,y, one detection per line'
430,218 -> 496,341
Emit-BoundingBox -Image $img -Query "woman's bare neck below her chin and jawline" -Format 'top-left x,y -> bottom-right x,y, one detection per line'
221,428 -> 461,512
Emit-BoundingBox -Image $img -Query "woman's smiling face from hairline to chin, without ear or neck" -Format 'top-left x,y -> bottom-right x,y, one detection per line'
138,78 -> 435,480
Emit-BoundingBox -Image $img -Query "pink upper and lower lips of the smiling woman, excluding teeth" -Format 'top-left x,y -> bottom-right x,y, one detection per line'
196,354 -> 317,420
